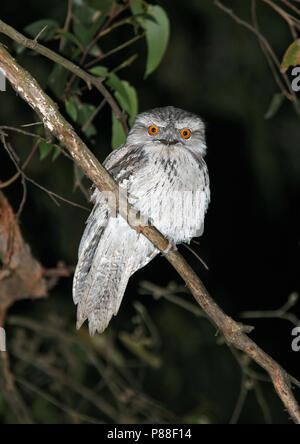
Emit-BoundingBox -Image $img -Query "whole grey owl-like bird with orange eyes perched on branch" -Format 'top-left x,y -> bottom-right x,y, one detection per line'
73,106 -> 210,336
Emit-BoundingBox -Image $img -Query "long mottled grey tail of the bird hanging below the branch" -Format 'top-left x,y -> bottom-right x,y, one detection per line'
73,217 -> 136,335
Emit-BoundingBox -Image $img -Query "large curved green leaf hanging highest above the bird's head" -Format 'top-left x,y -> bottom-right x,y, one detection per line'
143,6 -> 170,77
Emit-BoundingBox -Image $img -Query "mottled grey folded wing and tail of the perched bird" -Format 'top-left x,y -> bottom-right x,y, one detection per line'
73,145 -> 154,334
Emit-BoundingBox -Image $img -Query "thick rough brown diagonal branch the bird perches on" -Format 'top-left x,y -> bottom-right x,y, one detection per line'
0,41 -> 300,424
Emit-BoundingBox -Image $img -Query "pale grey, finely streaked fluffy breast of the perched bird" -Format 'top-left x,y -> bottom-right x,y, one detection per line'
128,148 -> 208,243
